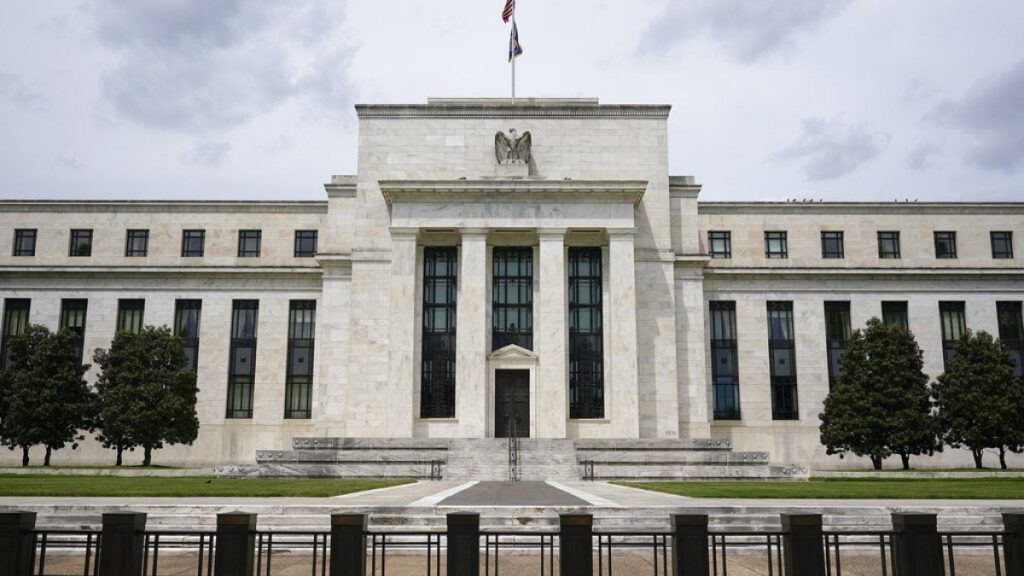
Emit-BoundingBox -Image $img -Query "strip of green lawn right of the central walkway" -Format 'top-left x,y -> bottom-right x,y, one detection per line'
618,478 -> 1024,500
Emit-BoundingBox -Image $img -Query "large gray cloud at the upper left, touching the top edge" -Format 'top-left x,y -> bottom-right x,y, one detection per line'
95,0 -> 351,132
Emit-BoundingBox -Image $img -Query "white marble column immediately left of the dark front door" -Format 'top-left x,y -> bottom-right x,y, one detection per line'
455,229 -> 488,438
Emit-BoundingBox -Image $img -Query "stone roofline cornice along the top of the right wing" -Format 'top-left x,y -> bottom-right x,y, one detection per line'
697,202 -> 1024,215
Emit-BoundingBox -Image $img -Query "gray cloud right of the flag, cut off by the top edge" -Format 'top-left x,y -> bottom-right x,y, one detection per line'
640,0 -> 852,61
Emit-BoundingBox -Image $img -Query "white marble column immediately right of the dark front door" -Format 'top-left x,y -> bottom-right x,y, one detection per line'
531,229 -> 569,438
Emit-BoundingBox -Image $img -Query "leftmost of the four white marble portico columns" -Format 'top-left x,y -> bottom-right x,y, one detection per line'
381,229 -> 419,438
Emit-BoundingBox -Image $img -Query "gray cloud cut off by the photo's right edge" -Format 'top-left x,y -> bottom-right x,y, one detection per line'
932,60 -> 1024,173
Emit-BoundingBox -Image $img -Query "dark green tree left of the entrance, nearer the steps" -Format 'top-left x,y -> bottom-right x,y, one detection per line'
93,326 -> 199,466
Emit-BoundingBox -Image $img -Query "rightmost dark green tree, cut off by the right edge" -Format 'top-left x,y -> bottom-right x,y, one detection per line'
932,330 -> 1024,468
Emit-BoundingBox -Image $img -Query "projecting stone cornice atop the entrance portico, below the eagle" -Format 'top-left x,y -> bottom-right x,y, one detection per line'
379,180 -> 647,205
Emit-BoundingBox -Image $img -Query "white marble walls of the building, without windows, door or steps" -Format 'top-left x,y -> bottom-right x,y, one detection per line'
0,99 -> 1024,466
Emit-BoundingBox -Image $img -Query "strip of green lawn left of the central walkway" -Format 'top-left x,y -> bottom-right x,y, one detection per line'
0,475 -> 412,497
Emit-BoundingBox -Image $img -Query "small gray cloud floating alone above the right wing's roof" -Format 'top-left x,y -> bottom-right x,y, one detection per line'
775,118 -> 890,180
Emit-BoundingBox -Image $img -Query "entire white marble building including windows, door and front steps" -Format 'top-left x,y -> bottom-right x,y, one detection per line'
0,98 -> 1024,478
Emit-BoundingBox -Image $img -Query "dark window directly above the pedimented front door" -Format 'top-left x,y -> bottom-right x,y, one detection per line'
490,248 -> 534,349
